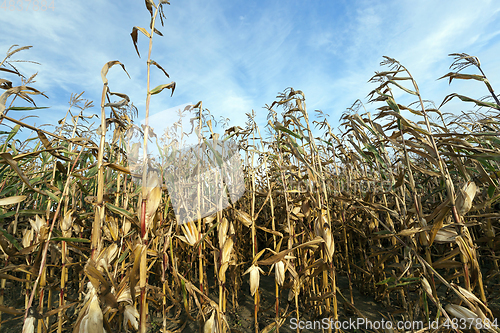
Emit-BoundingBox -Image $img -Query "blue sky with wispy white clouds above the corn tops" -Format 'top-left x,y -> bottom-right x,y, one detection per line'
0,0 -> 500,140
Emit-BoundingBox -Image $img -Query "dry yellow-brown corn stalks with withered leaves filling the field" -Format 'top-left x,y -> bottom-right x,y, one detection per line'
0,0 -> 500,333
